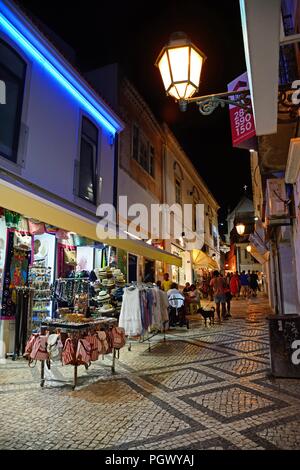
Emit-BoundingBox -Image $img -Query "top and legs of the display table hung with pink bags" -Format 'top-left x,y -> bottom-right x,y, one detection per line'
40,322 -> 120,390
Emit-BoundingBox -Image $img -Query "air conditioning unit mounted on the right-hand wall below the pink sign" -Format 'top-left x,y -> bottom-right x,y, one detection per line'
266,178 -> 289,219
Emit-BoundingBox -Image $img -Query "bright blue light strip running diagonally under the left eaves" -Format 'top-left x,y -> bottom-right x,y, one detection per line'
0,8 -> 121,135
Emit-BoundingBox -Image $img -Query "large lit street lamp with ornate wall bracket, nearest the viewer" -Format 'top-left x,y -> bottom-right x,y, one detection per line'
155,32 -> 252,115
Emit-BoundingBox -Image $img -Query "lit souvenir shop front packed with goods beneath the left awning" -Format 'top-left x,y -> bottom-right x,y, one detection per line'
0,209 -> 125,359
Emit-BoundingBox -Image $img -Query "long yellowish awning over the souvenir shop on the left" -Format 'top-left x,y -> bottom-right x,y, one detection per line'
0,180 -> 182,267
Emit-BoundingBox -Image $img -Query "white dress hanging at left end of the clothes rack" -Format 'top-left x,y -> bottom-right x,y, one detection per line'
119,287 -> 143,336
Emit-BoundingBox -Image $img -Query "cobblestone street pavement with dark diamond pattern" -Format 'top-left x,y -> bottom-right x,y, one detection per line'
0,298 -> 300,450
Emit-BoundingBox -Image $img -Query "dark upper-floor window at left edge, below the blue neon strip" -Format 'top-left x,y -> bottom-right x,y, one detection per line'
0,39 -> 26,162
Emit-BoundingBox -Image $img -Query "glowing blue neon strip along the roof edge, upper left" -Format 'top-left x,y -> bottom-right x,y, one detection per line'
0,2 -> 121,135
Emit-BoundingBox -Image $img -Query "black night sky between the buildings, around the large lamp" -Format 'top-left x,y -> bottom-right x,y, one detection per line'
18,0 -> 251,221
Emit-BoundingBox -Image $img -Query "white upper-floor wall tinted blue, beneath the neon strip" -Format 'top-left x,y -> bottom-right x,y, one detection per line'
0,32 -> 114,211
